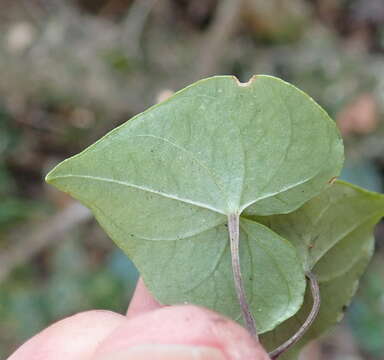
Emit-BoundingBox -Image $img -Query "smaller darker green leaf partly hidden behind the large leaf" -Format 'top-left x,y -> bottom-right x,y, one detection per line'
258,181 -> 384,359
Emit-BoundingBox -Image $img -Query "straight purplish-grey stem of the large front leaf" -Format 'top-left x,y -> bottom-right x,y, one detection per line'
228,214 -> 259,341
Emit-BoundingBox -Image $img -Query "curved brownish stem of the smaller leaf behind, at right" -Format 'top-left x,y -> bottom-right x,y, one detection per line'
268,271 -> 321,360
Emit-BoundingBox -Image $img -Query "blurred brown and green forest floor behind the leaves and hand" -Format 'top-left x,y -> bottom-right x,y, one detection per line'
0,0 -> 384,360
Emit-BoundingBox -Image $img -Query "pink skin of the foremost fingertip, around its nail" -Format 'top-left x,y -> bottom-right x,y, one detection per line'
95,305 -> 269,360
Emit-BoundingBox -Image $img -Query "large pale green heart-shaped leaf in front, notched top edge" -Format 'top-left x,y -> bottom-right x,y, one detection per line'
47,76 -> 343,332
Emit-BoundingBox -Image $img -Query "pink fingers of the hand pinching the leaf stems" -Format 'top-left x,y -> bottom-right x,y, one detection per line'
8,280 -> 269,360
